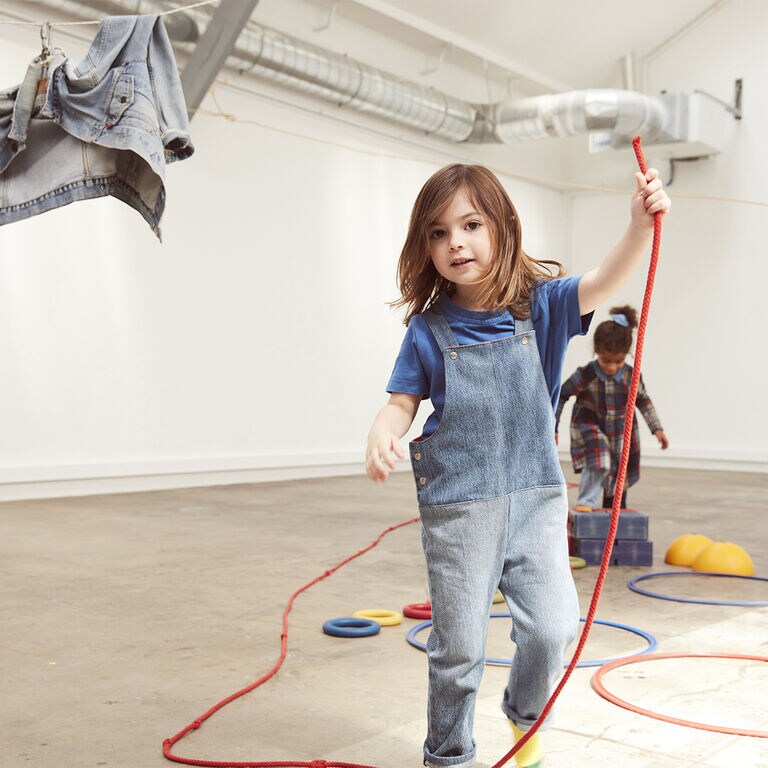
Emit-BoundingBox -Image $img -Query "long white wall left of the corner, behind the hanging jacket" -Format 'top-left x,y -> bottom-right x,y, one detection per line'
0,16 -> 567,499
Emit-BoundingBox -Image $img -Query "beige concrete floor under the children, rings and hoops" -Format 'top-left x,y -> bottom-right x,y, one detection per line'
0,469 -> 768,768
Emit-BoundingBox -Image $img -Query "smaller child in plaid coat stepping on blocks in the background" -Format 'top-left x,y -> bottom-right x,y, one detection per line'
555,306 -> 669,512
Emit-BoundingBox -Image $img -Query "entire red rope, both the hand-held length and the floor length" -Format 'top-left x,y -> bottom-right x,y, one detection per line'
163,136 -> 661,768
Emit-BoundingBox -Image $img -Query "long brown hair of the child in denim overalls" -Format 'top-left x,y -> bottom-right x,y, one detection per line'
392,163 -> 565,325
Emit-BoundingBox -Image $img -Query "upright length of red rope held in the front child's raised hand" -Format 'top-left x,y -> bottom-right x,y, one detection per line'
491,136 -> 662,768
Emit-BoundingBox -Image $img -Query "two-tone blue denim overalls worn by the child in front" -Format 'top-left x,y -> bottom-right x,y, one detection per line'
410,308 -> 579,766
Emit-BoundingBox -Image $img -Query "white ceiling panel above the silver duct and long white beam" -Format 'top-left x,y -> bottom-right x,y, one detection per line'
284,0 -> 731,92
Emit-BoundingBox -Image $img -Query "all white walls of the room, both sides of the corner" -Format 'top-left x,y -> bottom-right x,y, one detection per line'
0,0 -> 768,499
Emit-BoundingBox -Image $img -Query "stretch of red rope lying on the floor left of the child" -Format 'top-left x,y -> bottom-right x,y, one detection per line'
158,517 -> 419,768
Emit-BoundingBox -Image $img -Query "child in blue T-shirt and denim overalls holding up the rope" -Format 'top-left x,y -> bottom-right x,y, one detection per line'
366,165 -> 670,767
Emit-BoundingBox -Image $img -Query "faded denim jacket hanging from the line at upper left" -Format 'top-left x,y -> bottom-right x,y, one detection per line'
0,15 -> 194,237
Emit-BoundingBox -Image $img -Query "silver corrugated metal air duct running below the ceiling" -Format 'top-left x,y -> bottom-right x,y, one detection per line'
16,0 -> 666,143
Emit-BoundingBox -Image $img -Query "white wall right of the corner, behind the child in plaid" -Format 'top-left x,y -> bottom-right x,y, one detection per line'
561,0 -> 768,471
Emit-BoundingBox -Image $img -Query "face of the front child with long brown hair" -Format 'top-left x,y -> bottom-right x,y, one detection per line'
427,190 -> 491,298
